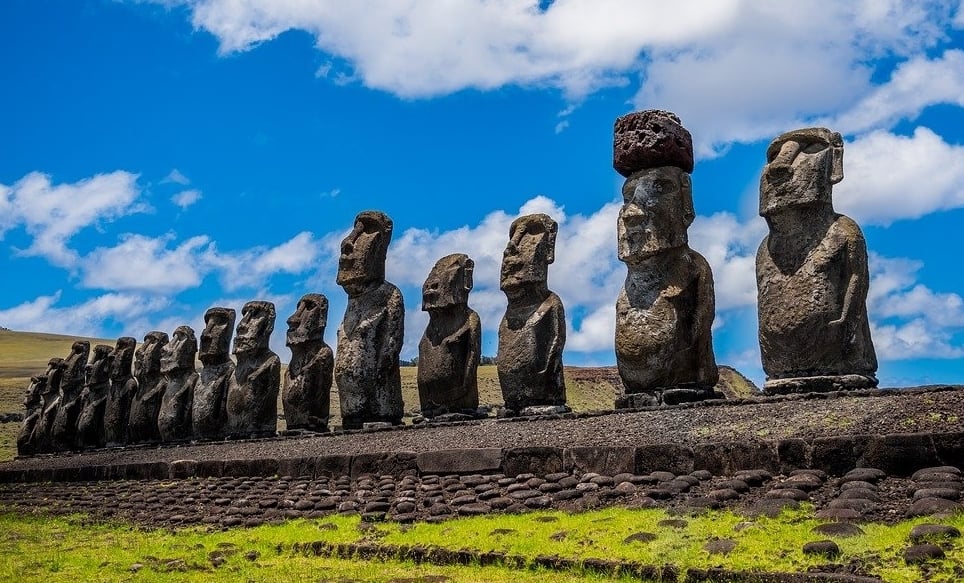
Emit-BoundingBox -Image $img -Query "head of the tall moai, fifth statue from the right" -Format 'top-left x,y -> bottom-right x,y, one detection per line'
335,211 -> 393,295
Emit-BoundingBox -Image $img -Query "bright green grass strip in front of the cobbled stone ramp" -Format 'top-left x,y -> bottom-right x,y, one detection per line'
0,508 -> 964,583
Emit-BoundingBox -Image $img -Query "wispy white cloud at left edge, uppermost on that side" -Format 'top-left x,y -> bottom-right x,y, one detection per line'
0,170 -> 147,267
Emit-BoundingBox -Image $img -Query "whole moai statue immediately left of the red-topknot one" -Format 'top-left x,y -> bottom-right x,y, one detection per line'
496,214 -> 569,415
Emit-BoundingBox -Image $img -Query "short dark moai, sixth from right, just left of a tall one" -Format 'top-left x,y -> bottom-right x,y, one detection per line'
281,294 -> 335,431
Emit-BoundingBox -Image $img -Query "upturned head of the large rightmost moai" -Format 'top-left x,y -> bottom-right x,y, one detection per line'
760,128 -> 843,217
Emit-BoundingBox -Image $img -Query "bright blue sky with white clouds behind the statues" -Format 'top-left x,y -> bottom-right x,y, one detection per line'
0,0 -> 964,386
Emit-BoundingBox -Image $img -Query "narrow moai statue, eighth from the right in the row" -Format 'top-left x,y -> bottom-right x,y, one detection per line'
191,307 -> 237,439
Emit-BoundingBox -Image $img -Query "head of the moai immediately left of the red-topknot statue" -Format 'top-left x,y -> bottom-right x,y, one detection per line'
499,213 -> 559,292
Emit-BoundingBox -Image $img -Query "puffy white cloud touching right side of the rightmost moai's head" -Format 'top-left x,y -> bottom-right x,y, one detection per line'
833,127 -> 964,225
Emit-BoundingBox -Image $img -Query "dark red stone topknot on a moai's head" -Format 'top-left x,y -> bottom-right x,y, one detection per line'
613,109 -> 693,177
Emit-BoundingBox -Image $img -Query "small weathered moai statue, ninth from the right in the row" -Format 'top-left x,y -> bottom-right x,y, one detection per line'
157,326 -> 198,441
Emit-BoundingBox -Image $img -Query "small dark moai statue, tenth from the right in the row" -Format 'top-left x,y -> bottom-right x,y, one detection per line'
128,330 -> 168,443
